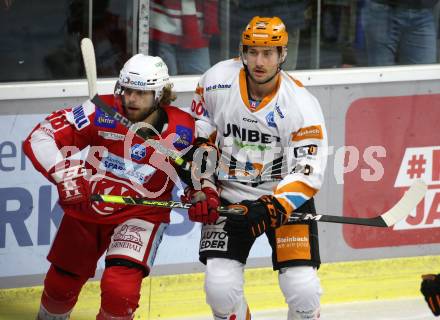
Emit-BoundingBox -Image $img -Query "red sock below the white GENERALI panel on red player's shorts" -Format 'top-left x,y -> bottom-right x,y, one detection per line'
96,266 -> 144,320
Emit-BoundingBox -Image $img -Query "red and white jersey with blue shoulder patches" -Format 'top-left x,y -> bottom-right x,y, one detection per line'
23,96 -> 194,223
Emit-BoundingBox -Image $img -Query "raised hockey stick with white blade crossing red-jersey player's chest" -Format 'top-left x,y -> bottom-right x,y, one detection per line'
81,38 -> 190,170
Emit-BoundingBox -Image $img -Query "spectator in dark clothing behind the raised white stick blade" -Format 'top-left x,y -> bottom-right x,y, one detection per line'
44,0 -> 131,79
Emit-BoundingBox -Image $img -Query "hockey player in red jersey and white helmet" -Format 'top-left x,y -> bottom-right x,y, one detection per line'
23,54 -> 194,320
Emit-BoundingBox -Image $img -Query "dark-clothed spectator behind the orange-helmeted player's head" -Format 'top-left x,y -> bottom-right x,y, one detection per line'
231,0 -> 310,70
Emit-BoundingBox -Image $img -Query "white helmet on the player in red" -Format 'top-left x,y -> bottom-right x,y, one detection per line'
117,53 -> 171,101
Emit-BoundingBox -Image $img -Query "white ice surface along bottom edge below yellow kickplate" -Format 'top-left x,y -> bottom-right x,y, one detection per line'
175,298 -> 438,320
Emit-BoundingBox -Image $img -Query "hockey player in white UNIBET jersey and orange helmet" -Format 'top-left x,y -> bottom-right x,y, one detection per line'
186,17 -> 327,320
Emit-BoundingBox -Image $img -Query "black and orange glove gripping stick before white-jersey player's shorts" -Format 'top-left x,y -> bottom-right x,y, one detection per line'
224,195 -> 289,238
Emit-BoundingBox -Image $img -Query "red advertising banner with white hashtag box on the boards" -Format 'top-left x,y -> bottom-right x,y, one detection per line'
343,94 -> 440,248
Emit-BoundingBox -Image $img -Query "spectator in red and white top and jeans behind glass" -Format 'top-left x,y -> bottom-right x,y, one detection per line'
150,0 -> 219,75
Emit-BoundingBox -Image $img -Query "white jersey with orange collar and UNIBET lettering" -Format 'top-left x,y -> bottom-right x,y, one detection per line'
191,59 -> 327,212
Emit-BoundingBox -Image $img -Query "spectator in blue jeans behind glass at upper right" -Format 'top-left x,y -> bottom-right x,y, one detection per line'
363,0 -> 438,66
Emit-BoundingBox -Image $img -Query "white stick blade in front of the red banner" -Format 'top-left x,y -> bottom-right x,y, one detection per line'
381,180 -> 428,227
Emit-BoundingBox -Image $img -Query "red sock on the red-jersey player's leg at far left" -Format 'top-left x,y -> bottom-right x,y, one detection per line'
41,265 -> 87,314
